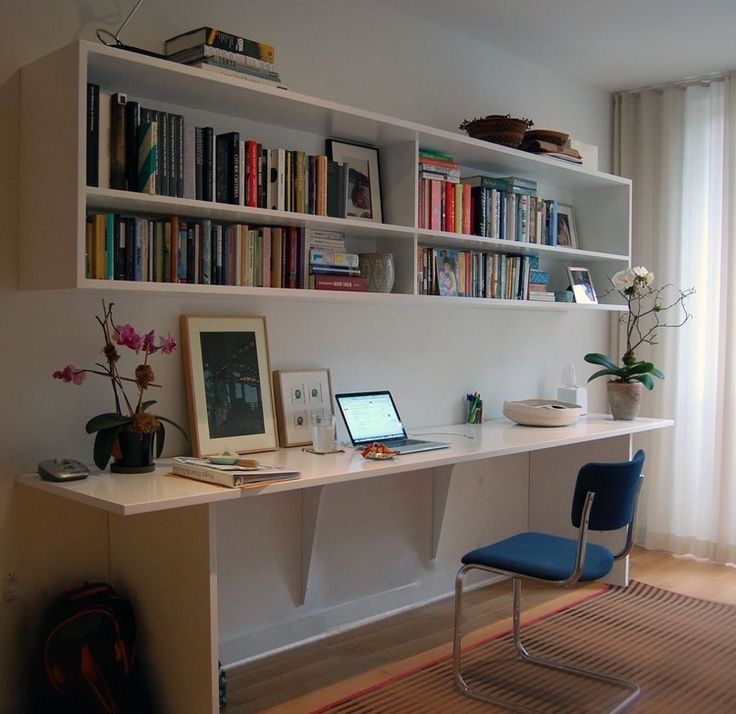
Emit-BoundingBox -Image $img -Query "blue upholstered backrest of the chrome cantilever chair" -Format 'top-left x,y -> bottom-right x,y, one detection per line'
571,449 -> 644,531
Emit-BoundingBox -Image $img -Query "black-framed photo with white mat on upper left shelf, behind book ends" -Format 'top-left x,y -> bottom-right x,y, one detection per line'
327,139 -> 383,223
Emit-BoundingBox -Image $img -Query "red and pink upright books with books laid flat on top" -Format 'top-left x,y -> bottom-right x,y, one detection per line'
417,149 -> 472,234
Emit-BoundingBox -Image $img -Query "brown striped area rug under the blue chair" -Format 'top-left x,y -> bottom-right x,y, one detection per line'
315,581 -> 736,714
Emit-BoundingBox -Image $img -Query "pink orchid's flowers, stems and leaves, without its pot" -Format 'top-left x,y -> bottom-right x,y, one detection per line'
53,300 -> 186,469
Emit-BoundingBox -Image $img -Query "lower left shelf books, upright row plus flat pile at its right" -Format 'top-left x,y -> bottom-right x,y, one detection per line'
86,213 -> 356,290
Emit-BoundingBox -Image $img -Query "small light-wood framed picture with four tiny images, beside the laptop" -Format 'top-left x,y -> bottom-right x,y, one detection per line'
273,369 -> 332,446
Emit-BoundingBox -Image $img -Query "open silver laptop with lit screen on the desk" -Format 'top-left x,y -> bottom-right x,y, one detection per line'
335,390 -> 450,454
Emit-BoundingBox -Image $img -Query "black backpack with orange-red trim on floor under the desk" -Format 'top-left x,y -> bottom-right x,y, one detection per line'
30,583 -> 151,714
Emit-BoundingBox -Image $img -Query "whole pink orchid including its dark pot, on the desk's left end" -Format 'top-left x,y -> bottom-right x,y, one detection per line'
53,300 -> 186,473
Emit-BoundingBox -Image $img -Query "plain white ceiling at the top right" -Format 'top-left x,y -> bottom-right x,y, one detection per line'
385,0 -> 736,91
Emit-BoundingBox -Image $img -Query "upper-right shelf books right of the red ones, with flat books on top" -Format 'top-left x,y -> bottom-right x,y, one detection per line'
460,176 -> 557,245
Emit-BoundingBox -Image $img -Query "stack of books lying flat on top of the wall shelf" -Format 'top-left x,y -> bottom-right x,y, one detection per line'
164,27 -> 287,89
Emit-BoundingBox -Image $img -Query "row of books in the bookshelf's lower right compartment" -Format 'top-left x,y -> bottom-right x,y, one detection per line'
417,247 -> 541,300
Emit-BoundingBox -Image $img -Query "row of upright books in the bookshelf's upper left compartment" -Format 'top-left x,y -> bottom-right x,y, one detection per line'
87,83 -> 350,218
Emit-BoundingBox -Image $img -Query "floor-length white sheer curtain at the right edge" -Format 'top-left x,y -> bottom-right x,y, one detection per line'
614,75 -> 736,563
